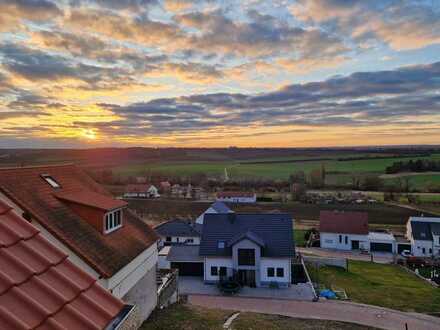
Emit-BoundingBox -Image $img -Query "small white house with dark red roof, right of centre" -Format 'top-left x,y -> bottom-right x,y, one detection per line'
319,211 -> 369,250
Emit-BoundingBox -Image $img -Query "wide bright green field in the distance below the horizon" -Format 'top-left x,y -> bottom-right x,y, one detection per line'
112,154 -> 440,188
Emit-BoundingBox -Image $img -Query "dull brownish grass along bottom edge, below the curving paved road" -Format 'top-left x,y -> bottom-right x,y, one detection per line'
140,304 -> 373,330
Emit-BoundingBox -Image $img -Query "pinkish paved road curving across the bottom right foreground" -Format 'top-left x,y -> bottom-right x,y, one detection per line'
188,295 -> 440,330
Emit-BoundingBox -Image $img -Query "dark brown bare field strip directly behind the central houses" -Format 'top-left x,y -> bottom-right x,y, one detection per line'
128,199 -> 430,227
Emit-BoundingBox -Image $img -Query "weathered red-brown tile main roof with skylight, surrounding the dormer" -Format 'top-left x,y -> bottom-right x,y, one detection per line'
0,164 -> 158,278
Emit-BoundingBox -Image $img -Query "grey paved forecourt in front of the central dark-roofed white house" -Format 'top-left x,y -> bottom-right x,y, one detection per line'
179,276 -> 314,301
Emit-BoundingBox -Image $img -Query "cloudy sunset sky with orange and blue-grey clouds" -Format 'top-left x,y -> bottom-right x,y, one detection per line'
0,0 -> 440,147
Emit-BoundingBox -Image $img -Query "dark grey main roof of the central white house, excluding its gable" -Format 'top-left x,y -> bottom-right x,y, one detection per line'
200,213 -> 295,257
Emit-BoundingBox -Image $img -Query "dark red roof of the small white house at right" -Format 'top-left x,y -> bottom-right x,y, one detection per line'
319,211 -> 368,235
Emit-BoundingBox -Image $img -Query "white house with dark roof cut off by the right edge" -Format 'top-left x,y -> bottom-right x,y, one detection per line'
406,217 -> 440,257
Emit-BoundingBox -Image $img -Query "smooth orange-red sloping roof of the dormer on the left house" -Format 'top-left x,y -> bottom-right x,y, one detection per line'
55,191 -> 128,211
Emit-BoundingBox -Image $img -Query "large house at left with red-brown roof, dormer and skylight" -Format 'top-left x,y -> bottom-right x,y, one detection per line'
0,165 -> 159,321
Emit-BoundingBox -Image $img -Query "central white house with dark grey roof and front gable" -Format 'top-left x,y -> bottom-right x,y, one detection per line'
199,213 -> 295,287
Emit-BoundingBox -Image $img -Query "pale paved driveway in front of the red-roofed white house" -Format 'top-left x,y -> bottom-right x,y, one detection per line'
297,247 -> 393,264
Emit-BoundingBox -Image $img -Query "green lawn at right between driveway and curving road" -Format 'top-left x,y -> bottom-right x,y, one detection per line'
308,260 -> 440,313
